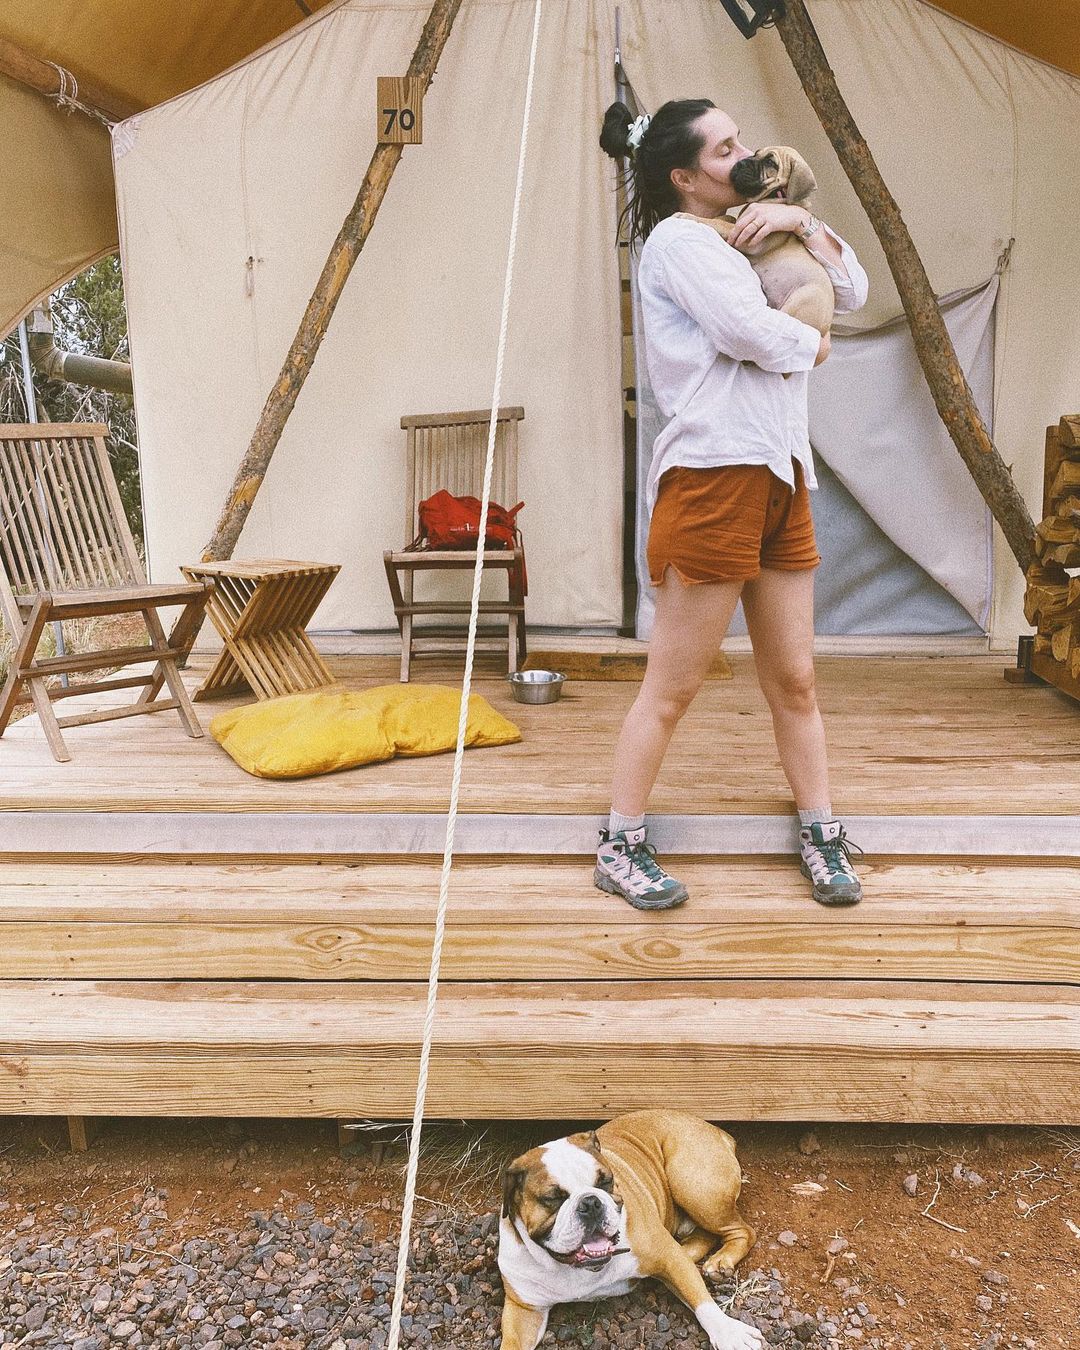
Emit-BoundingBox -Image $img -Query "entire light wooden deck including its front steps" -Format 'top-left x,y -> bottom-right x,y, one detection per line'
0,656 -> 1080,1123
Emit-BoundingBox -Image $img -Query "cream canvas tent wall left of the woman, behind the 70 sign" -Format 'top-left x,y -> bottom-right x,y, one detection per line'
115,0 -> 622,629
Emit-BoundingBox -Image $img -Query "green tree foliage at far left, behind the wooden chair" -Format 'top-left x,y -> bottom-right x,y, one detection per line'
0,257 -> 143,549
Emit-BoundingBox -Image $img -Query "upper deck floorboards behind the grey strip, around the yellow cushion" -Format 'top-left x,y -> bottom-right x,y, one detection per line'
0,655 -> 1080,815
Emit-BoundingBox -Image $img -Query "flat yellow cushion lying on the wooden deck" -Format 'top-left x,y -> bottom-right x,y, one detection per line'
211,684 -> 521,778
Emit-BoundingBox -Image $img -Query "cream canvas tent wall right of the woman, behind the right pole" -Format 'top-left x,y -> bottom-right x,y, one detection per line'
622,0 -> 1080,649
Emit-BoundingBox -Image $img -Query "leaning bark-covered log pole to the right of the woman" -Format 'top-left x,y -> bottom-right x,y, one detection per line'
776,0 -> 1035,571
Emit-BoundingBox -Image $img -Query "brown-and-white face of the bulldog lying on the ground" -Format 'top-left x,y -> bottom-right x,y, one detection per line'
502,1131 -> 628,1270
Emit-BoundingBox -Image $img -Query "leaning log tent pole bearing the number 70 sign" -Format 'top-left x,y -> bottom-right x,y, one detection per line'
203,0 -> 462,563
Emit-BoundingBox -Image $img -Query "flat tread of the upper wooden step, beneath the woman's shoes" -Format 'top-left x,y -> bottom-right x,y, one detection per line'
0,855 -> 1080,932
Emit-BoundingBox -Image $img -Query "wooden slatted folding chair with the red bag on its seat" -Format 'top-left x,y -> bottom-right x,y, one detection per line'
383,408 -> 525,680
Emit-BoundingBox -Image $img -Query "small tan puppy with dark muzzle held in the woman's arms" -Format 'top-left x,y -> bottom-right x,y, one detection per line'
678,146 -> 834,333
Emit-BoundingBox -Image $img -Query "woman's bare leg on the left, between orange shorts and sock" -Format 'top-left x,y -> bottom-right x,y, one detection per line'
612,568 -> 744,815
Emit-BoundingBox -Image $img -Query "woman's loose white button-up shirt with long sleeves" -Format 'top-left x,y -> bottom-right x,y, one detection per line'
637,216 -> 868,513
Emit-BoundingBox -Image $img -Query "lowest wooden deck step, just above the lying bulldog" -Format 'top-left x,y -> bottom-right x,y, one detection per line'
0,980 -> 1080,1125
